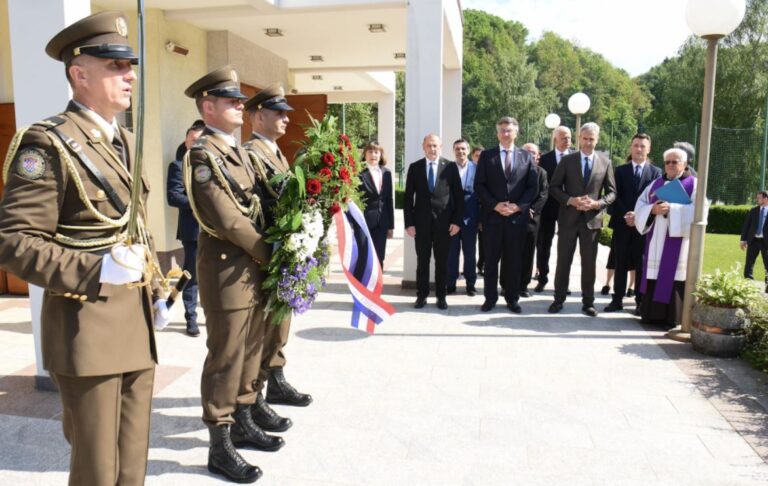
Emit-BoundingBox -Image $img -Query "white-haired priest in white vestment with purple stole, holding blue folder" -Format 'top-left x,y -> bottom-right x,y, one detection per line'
628,148 -> 696,327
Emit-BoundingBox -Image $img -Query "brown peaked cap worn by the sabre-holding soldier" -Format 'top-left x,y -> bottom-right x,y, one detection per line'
45,11 -> 139,64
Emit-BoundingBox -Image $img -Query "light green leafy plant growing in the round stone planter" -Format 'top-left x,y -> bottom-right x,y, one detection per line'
693,263 -> 761,309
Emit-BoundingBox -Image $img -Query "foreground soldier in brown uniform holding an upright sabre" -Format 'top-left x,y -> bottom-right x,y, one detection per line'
0,12 -> 167,486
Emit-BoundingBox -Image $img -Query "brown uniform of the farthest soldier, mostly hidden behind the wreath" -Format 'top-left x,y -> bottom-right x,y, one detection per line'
244,135 -> 291,392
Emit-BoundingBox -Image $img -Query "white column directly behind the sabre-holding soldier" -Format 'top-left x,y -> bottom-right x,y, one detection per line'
8,0 -> 91,389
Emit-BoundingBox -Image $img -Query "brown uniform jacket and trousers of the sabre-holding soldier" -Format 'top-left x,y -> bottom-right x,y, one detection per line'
0,103 -> 159,486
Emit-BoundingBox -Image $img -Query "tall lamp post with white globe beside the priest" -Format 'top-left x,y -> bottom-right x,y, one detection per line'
667,0 -> 746,341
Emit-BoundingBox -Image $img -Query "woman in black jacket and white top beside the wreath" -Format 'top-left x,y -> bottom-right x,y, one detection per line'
360,142 -> 395,268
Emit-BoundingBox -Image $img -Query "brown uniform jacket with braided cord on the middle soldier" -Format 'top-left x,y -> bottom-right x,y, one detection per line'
184,128 -> 271,311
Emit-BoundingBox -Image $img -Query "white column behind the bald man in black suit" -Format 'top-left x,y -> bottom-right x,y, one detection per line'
402,0 -> 450,287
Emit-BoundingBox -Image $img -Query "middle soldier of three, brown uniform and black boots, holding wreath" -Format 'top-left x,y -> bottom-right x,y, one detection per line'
184,66 -> 284,482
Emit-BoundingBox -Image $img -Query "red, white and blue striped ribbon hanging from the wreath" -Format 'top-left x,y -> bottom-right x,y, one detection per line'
333,202 -> 395,334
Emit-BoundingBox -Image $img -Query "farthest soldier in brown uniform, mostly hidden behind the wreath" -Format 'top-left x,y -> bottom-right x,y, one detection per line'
244,83 -> 312,422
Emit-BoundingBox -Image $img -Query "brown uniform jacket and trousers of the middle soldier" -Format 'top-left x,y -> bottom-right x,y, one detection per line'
184,129 -> 270,426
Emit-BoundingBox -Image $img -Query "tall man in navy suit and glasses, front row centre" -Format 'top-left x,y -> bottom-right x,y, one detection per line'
475,116 -> 538,314
